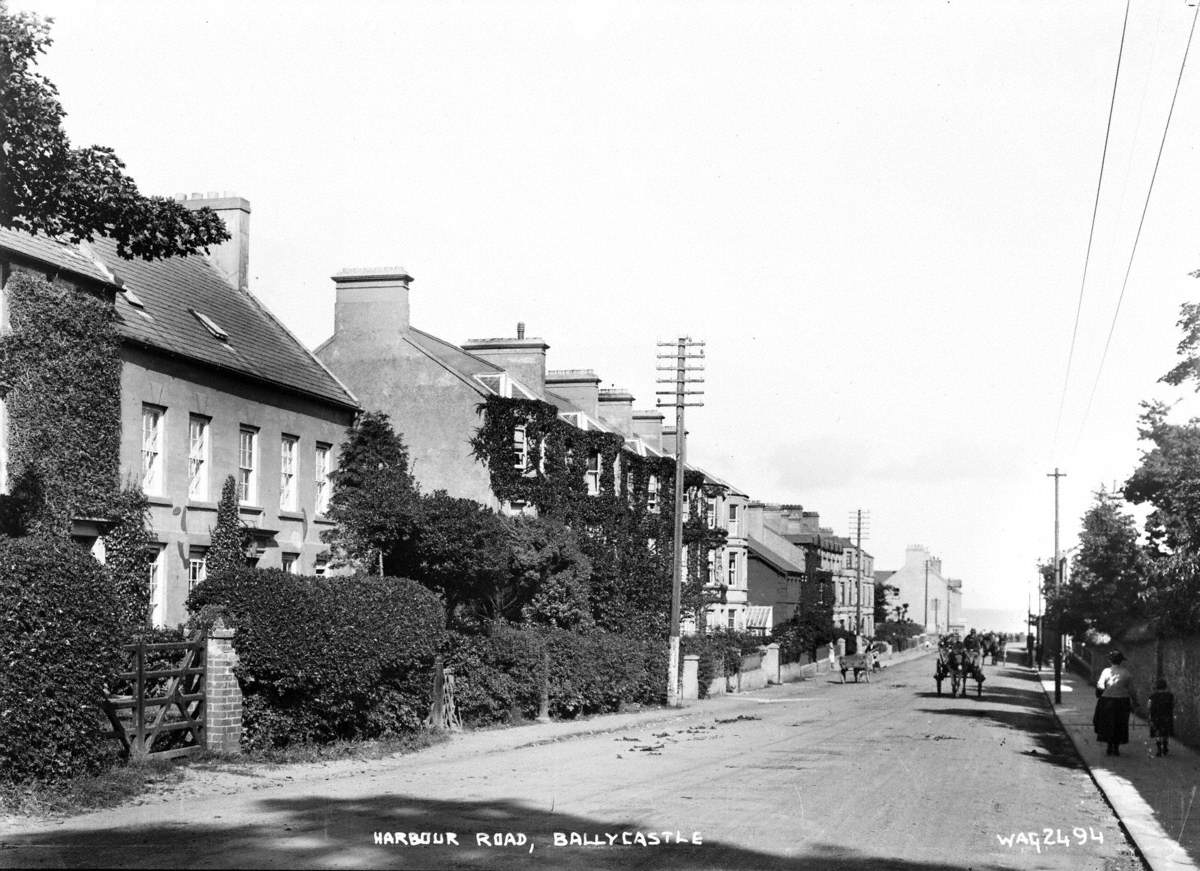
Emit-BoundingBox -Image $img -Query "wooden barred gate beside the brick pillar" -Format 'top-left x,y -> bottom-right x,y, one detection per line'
101,632 -> 206,758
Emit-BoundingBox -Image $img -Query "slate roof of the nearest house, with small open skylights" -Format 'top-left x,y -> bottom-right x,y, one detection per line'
0,229 -> 359,408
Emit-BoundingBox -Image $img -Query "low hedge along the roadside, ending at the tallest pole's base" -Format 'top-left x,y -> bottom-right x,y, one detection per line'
446,624 -> 667,726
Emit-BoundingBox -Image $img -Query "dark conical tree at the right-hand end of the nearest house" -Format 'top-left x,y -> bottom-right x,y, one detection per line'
322,412 -> 420,575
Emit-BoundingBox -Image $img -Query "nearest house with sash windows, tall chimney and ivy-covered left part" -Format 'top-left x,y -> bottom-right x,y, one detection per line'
0,197 -> 360,625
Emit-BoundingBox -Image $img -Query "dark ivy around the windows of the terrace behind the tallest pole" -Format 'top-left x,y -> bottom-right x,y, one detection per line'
472,396 -> 725,635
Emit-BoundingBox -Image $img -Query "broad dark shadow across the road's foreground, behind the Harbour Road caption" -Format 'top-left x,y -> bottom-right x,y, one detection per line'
0,794 -> 1000,871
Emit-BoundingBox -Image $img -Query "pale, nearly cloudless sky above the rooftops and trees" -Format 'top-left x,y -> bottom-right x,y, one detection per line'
10,0 -> 1200,628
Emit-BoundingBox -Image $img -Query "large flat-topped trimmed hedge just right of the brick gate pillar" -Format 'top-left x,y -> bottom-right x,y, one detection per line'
188,569 -> 445,749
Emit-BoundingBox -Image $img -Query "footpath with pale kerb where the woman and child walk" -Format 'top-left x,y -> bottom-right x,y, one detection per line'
1039,668 -> 1200,871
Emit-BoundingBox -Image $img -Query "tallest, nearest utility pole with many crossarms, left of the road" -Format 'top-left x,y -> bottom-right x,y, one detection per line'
655,336 -> 704,708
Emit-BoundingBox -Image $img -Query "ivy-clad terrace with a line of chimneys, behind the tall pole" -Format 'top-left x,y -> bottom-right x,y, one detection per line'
316,268 -> 725,633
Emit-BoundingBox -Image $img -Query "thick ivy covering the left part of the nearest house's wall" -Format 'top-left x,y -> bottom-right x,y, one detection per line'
0,271 -> 152,632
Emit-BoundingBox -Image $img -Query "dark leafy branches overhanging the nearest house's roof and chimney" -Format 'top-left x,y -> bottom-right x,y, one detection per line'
0,0 -> 229,260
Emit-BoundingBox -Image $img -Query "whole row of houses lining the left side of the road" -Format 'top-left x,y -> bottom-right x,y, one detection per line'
0,194 -> 954,636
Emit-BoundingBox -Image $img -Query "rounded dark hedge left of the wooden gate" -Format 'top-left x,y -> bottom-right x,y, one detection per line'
0,535 -> 125,782
